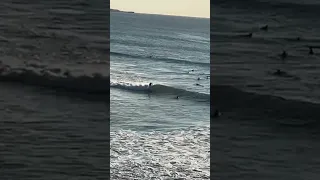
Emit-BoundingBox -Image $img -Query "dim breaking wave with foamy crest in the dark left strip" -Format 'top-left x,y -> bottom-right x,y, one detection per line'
0,61 -> 110,94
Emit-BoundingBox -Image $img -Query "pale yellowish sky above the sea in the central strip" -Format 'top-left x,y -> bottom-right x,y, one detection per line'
110,0 -> 210,18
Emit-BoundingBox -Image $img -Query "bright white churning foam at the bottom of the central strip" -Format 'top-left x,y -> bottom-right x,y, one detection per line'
110,127 -> 210,180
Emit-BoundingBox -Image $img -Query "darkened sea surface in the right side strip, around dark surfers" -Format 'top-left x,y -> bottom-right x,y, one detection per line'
211,0 -> 320,180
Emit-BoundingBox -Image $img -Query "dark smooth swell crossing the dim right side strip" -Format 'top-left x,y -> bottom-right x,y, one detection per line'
211,85 -> 320,125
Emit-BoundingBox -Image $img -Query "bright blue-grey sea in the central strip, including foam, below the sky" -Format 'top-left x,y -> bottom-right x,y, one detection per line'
110,12 -> 210,180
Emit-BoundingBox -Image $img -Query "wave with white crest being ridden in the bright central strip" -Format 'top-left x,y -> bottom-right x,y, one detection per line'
110,83 -> 210,102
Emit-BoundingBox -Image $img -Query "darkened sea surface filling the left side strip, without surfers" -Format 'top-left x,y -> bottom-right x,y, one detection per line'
0,0 -> 109,180
